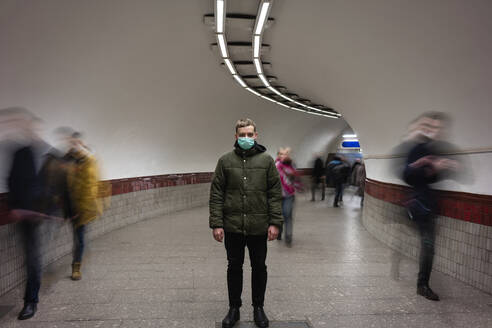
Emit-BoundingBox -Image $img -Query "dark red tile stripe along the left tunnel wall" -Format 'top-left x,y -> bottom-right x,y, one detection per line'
0,172 -> 213,225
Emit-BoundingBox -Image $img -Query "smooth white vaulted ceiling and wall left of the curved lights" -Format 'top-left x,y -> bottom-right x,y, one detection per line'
0,0 -> 346,182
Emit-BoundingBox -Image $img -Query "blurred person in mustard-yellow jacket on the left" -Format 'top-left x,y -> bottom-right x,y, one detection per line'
56,127 -> 102,280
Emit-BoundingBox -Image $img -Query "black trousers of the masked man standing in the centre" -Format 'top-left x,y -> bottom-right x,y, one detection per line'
224,232 -> 267,307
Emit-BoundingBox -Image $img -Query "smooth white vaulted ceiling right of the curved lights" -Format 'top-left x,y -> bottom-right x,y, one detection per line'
265,0 -> 492,155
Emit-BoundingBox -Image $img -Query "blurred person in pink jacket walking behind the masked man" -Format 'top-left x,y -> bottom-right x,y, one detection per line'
275,147 -> 299,247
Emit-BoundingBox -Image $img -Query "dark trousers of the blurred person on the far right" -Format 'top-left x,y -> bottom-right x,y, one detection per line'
416,215 -> 436,286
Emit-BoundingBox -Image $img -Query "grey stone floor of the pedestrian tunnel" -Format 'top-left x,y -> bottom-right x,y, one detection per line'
0,188 -> 492,328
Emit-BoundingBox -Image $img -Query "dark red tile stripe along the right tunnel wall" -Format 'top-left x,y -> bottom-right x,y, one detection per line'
366,179 -> 492,226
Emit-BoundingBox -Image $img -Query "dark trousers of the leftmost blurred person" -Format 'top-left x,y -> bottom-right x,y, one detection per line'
20,221 -> 41,303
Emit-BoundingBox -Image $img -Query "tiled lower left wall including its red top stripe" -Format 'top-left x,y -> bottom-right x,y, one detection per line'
0,173 -> 212,295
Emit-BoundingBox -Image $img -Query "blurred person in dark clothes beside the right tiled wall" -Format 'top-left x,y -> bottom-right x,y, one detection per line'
400,112 -> 461,301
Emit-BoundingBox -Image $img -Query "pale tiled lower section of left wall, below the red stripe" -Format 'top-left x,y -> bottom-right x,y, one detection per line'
0,183 -> 210,295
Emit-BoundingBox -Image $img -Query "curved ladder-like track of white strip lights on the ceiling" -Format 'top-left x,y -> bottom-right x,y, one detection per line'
204,0 -> 341,118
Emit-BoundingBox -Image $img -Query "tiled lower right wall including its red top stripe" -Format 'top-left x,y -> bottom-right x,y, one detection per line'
362,179 -> 492,293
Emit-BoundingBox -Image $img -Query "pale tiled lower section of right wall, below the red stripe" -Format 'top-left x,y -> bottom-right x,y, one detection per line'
363,193 -> 492,293
